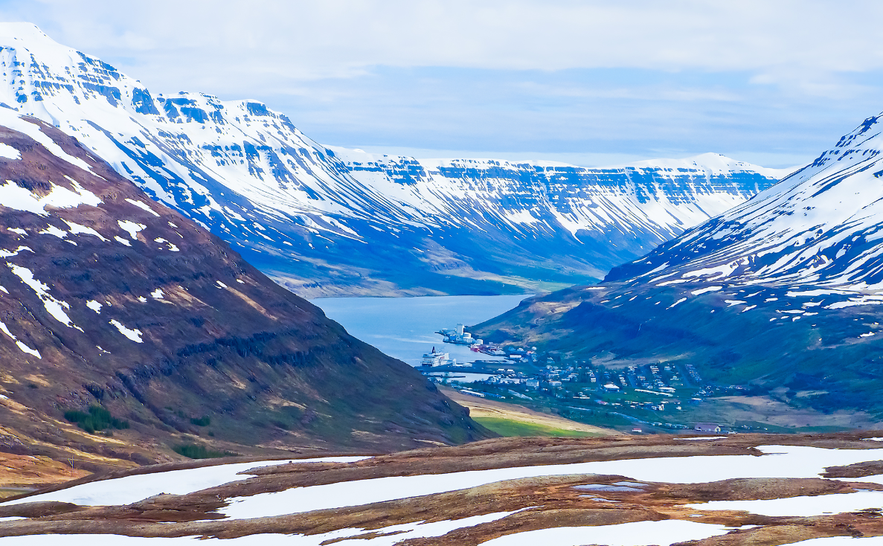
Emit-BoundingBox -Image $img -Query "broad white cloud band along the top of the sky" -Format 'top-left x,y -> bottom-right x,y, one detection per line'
2,0 -> 883,79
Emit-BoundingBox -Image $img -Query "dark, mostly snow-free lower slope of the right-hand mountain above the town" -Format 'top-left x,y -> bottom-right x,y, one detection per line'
473,284 -> 883,424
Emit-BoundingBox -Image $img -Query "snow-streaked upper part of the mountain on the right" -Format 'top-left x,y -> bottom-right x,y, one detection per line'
611,111 -> 883,292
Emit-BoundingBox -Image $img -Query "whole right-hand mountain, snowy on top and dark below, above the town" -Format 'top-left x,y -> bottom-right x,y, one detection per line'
474,111 -> 883,424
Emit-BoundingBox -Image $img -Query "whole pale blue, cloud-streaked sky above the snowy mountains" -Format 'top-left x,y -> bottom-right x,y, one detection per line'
0,0 -> 883,167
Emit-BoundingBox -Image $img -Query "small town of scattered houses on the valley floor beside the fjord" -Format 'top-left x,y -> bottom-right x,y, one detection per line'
421,325 -> 765,434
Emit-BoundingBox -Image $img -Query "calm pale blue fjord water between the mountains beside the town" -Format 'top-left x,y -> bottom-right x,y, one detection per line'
312,295 -> 530,366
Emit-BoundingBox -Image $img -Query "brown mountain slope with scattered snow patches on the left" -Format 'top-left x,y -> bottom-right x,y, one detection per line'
0,112 -> 487,466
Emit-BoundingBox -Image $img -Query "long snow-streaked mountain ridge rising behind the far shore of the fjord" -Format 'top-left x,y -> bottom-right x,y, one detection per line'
0,23 -> 784,295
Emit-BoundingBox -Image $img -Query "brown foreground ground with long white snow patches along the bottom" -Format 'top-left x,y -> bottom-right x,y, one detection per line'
0,433 -> 883,546
